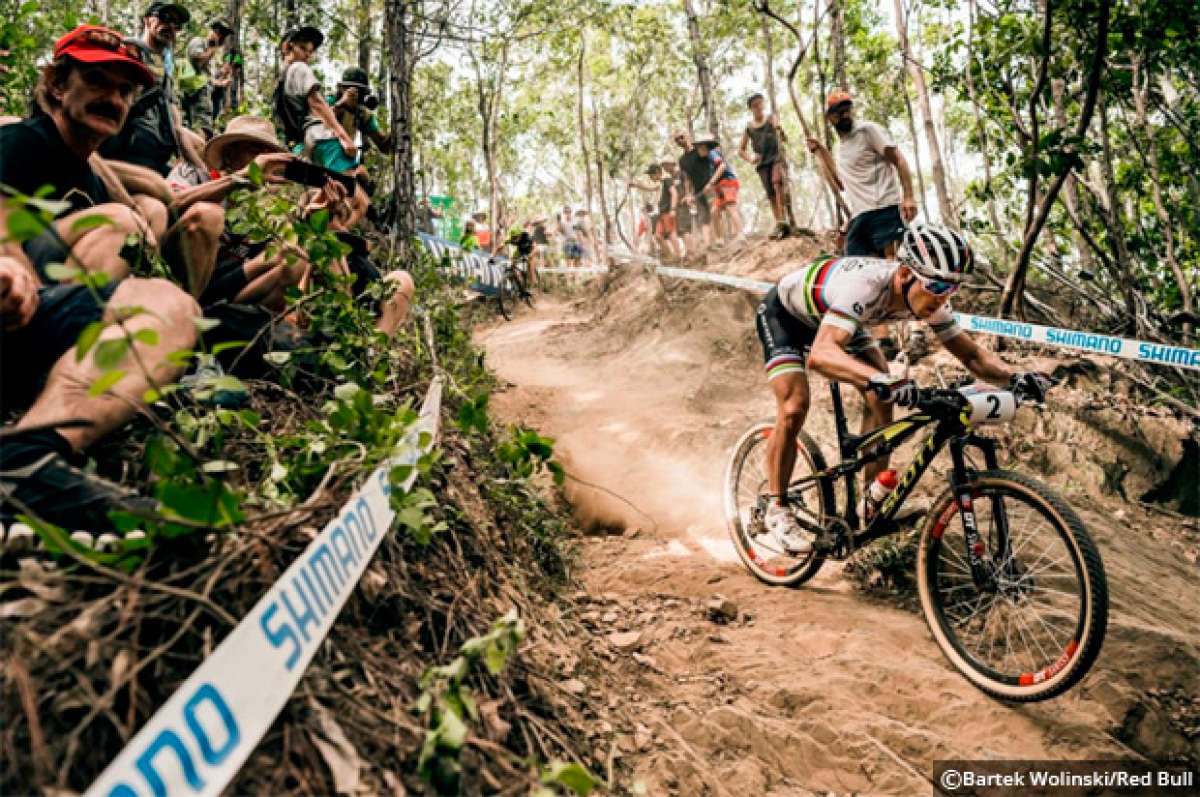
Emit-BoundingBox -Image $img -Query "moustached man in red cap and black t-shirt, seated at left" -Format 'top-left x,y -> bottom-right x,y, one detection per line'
0,25 -> 199,531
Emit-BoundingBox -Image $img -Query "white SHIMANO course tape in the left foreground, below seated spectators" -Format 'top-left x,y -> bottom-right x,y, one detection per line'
86,377 -> 442,797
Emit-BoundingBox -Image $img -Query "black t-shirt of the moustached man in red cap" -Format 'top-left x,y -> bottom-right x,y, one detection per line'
0,115 -> 110,212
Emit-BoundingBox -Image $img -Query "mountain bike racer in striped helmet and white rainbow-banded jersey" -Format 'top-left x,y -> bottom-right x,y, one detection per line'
755,224 -> 1050,555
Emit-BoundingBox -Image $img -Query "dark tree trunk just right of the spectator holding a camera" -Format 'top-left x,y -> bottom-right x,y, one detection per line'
384,0 -> 416,260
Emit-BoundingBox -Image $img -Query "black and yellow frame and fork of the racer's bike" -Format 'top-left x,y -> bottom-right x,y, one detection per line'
788,382 -> 1010,586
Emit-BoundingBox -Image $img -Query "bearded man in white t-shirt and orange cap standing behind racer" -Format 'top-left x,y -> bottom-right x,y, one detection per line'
808,91 -> 917,258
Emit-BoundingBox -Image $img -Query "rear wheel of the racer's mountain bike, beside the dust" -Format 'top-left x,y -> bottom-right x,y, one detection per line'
725,420 -> 835,587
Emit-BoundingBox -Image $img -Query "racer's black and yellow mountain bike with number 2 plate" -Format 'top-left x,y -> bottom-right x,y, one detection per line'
725,382 -> 1109,702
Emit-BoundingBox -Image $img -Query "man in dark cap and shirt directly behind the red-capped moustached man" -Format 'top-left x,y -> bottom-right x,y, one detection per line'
100,0 -> 203,176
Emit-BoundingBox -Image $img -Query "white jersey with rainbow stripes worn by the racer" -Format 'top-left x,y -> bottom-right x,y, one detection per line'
778,254 -> 962,343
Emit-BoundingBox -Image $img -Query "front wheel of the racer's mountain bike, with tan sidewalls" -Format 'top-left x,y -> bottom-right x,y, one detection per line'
917,471 -> 1109,702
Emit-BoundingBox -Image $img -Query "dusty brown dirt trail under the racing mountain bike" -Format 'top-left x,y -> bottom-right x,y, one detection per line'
479,272 -> 1200,795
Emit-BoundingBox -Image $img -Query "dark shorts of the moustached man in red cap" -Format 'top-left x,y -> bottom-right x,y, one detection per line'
0,281 -> 119,414
